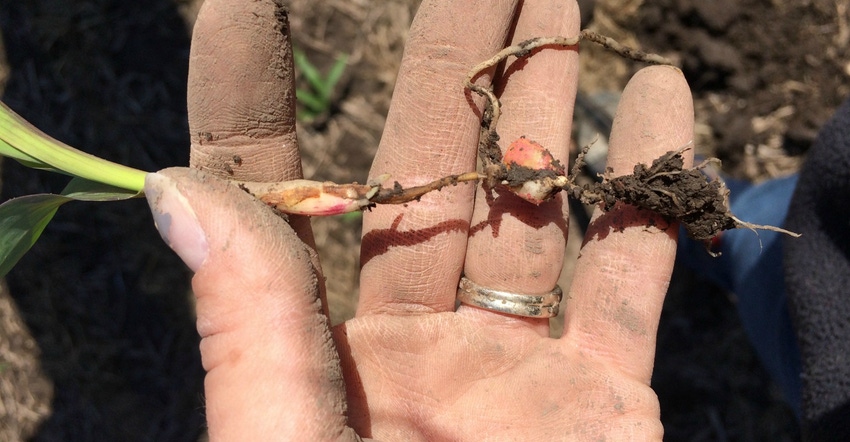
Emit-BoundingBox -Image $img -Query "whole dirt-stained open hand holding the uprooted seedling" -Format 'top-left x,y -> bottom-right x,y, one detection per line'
146,0 -> 693,440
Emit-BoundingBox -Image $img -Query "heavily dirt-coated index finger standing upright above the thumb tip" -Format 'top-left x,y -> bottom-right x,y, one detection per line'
188,0 -> 301,182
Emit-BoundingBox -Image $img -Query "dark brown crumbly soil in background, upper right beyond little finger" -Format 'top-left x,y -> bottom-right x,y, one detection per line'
635,0 -> 850,179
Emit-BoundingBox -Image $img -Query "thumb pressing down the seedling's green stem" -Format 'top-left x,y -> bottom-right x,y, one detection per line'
145,168 -> 346,440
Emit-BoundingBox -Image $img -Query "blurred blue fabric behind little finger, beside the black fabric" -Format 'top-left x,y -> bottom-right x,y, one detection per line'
677,175 -> 801,416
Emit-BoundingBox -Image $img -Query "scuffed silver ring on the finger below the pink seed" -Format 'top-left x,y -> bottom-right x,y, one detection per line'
457,276 -> 564,318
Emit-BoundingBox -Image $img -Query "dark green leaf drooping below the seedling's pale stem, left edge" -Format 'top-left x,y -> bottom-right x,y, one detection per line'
0,178 -> 141,278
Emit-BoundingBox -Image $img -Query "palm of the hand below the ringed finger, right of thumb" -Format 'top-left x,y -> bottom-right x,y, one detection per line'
336,313 -> 662,441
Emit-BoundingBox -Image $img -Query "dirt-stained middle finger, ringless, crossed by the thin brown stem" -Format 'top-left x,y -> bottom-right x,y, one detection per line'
358,0 -> 516,315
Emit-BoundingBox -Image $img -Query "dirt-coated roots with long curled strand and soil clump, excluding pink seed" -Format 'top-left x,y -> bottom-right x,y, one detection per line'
458,30 -> 797,249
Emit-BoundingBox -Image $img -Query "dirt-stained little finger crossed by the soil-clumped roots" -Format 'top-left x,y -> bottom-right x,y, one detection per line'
562,66 -> 694,384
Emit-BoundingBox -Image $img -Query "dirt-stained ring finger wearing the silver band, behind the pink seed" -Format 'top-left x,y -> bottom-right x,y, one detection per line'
459,0 -> 579,336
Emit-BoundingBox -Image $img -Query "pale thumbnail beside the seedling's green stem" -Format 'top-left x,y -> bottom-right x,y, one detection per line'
145,173 -> 209,271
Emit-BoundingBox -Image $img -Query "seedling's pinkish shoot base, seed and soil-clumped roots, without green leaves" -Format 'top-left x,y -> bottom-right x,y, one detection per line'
244,30 -> 799,249
